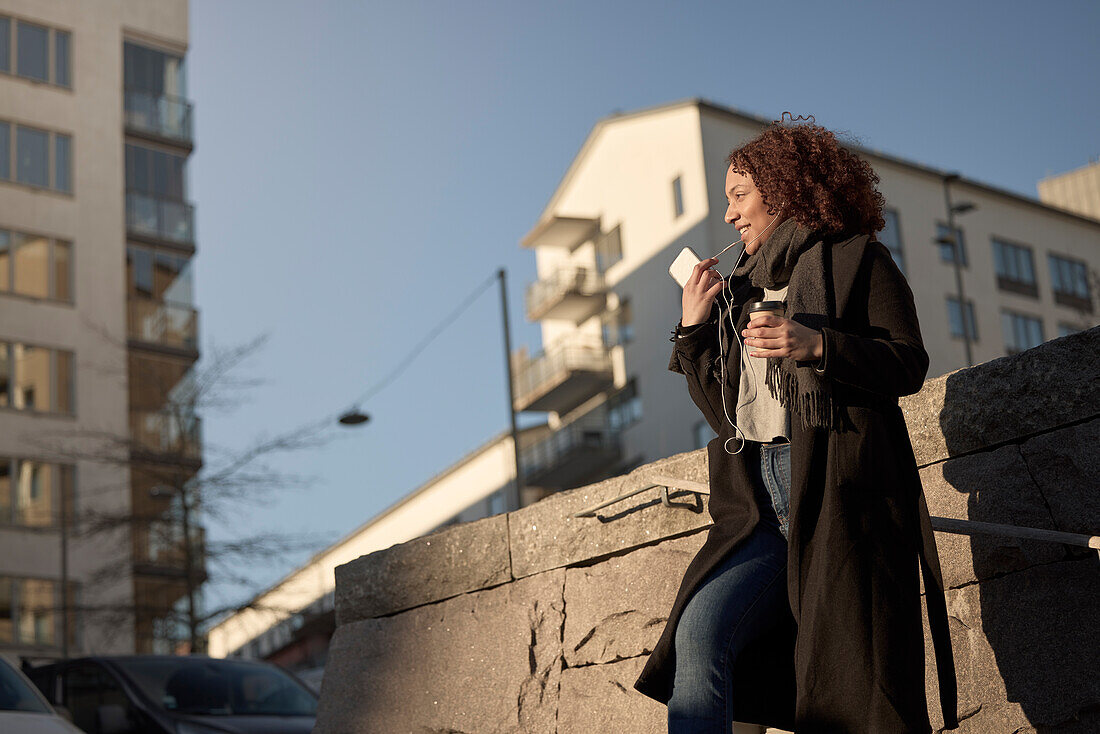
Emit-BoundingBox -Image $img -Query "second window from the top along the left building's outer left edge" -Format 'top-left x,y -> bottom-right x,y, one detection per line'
0,121 -> 73,194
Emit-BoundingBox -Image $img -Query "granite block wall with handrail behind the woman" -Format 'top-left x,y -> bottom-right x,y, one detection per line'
316,327 -> 1100,734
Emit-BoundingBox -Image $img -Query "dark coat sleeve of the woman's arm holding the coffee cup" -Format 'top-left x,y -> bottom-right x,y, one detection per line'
814,241 -> 928,397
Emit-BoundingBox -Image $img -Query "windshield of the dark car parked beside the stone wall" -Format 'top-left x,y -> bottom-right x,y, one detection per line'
116,657 -> 317,716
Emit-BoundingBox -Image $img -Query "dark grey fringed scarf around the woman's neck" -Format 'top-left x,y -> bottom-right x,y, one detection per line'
730,218 -> 842,430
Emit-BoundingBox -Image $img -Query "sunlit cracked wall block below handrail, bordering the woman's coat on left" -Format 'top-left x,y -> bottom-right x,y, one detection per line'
562,533 -> 706,669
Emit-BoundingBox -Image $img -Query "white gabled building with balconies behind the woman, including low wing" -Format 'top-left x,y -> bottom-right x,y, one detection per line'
210,99 -> 1100,677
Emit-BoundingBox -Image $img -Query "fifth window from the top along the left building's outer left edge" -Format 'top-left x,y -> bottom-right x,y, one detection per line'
0,457 -> 74,527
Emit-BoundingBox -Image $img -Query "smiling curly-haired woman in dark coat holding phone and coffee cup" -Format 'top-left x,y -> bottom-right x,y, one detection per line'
635,119 -> 957,734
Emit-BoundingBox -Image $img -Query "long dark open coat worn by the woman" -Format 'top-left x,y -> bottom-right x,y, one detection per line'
635,235 -> 958,734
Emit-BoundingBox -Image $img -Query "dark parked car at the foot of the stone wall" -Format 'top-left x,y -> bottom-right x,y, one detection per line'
29,655 -> 317,734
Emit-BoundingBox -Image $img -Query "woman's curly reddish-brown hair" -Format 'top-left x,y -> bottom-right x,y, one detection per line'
727,112 -> 886,234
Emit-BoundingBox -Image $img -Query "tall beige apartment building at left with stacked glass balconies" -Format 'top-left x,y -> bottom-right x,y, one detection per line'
0,0 -> 202,659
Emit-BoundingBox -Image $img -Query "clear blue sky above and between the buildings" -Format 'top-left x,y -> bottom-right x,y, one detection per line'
188,0 -> 1100,601
